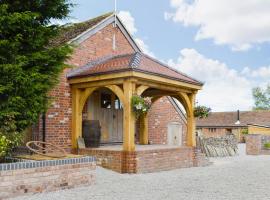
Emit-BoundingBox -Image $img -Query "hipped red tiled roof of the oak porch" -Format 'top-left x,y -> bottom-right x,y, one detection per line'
68,52 -> 202,85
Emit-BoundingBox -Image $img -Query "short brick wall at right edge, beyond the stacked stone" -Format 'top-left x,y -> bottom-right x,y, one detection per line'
246,134 -> 270,155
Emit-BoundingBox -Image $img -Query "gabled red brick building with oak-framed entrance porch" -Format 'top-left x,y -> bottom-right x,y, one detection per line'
33,13 -> 209,172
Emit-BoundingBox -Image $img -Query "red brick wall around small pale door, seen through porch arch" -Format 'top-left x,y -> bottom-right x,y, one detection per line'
148,97 -> 187,145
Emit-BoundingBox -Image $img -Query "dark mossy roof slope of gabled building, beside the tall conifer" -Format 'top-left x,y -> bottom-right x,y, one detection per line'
50,12 -> 113,46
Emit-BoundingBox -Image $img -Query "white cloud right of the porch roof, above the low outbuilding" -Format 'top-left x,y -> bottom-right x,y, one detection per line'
169,49 -> 255,111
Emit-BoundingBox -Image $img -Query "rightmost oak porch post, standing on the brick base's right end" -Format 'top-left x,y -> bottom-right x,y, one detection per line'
187,94 -> 196,147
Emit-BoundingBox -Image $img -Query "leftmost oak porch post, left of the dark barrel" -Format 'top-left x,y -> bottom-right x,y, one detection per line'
71,88 -> 82,148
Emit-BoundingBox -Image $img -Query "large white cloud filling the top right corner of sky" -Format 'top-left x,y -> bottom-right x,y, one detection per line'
165,0 -> 270,51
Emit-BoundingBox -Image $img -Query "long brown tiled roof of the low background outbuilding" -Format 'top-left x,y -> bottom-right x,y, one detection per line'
196,111 -> 270,127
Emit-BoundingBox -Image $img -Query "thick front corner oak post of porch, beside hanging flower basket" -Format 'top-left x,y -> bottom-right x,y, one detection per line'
123,81 -> 135,151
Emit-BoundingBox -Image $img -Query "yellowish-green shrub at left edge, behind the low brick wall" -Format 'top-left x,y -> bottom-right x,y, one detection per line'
0,117 -> 23,162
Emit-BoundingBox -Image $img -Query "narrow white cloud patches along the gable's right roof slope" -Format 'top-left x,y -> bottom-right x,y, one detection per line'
118,11 -> 155,57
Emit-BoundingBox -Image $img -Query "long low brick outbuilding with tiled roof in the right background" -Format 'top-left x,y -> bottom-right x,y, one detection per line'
196,111 -> 270,141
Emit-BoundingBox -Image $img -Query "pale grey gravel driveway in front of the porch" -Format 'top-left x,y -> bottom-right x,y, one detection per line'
10,145 -> 270,200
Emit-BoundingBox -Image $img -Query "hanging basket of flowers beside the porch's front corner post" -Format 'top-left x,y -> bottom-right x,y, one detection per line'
131,95 -> 152,119
